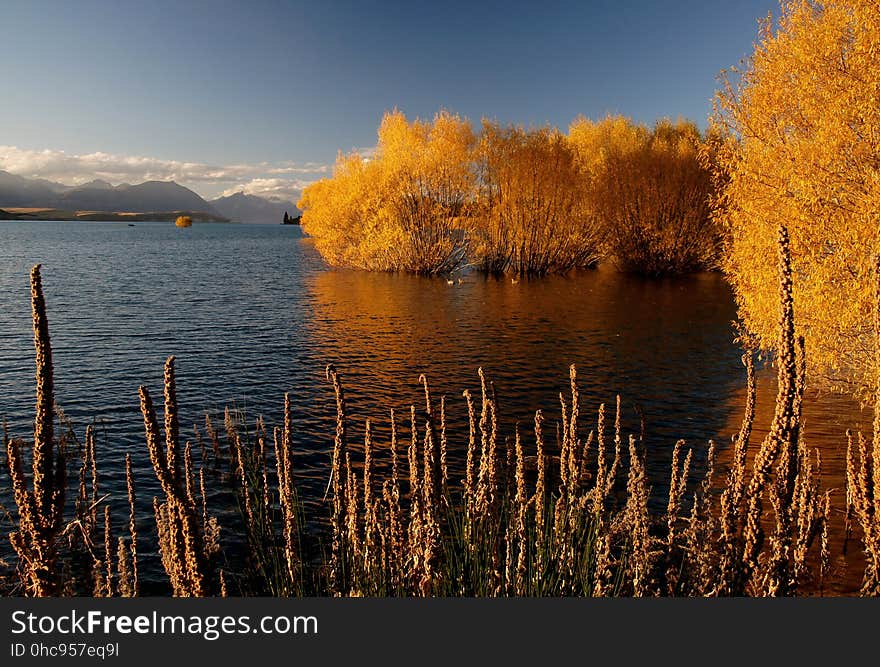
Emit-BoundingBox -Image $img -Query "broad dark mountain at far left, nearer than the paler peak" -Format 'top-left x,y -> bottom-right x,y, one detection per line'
0,171 -> 227,220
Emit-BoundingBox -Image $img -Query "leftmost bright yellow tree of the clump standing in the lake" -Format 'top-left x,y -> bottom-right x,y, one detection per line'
298,111 -> 475,274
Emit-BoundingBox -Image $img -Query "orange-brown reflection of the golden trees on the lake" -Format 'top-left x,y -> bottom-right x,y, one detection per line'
306,270 -> 741,490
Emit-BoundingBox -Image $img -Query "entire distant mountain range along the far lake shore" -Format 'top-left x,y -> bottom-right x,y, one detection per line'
0,170 -> 299,223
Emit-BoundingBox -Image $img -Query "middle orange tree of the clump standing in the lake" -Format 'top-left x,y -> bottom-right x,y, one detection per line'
473,120 -> 601,275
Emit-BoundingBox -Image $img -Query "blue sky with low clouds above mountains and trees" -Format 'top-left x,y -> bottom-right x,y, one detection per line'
0,0 -> 778,196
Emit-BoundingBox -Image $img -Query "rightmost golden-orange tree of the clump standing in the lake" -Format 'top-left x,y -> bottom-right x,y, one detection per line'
569,117 -> 719,275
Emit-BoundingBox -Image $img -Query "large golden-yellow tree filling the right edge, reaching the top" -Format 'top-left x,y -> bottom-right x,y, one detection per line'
717,0 -> 880,391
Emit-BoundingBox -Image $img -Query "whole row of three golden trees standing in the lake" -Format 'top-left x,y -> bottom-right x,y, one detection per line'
298,111 -> 718,275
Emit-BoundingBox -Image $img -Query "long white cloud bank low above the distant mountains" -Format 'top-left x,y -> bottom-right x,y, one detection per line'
0,145 -> 330,199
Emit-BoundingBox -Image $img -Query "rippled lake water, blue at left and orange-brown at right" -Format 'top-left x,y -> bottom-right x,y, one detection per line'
0,222 -> 870,596
